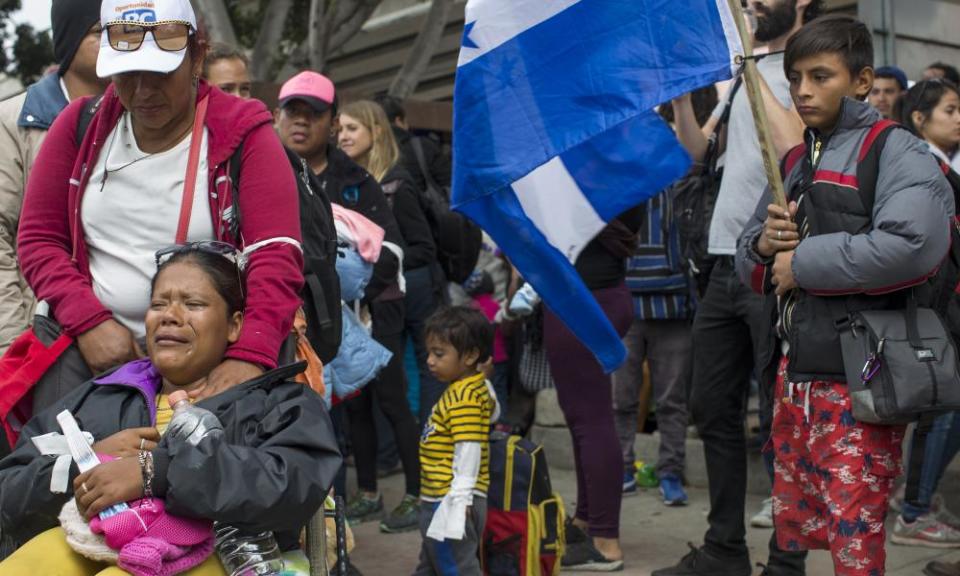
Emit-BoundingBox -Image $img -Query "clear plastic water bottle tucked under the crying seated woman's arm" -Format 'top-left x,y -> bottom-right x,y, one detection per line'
167,390 -> 283,576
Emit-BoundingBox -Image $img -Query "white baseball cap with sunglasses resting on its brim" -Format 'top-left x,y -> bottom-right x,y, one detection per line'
97,0 -> 197,78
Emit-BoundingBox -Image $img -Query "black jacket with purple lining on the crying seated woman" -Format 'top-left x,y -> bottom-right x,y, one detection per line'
0,360 -> 341,550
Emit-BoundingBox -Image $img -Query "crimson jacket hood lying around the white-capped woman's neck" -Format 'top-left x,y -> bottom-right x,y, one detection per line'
94,80 -> 273,166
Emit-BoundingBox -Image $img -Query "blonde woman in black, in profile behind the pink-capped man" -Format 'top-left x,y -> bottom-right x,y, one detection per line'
338,100 -> 443,532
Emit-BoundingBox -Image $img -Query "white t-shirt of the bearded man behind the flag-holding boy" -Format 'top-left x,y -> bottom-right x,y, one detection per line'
708,54 -> 793,256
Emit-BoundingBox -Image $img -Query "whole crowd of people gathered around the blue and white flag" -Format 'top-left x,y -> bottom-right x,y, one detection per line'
0,0 -> 960,576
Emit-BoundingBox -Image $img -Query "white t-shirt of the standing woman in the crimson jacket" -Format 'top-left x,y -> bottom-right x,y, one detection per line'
80,112 -> 214,341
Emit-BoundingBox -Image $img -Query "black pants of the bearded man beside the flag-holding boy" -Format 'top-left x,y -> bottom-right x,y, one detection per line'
690,257 -> 805,574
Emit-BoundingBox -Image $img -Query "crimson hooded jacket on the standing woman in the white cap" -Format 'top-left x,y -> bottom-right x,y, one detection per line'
17,82 -> 303,368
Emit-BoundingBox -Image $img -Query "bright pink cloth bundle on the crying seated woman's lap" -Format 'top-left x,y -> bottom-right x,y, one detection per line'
90,498 -> 214,576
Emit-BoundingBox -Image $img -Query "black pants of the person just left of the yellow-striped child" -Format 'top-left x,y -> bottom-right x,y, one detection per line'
346,300 -> 420,496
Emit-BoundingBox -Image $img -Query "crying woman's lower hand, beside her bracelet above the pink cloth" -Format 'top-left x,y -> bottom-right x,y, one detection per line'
73,458 -> 143,521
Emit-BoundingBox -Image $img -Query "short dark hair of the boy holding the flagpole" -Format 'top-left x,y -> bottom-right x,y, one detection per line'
783,14 -> 873,77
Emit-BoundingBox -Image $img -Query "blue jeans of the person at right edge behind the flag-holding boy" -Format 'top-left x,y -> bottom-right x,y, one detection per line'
902,412 -> 960,522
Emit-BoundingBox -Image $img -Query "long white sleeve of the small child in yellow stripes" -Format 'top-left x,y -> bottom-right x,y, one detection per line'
427,442 -> 481,541
